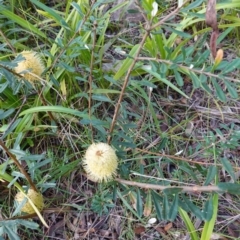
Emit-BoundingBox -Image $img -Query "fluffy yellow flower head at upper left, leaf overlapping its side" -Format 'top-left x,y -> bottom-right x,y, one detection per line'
14,51 -> 45,82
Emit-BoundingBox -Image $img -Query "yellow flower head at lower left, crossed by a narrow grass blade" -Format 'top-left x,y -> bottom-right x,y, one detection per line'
15,189 -> 44,214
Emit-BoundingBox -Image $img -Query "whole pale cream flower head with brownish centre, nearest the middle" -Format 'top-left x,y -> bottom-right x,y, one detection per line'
83,143 -> 118,182
